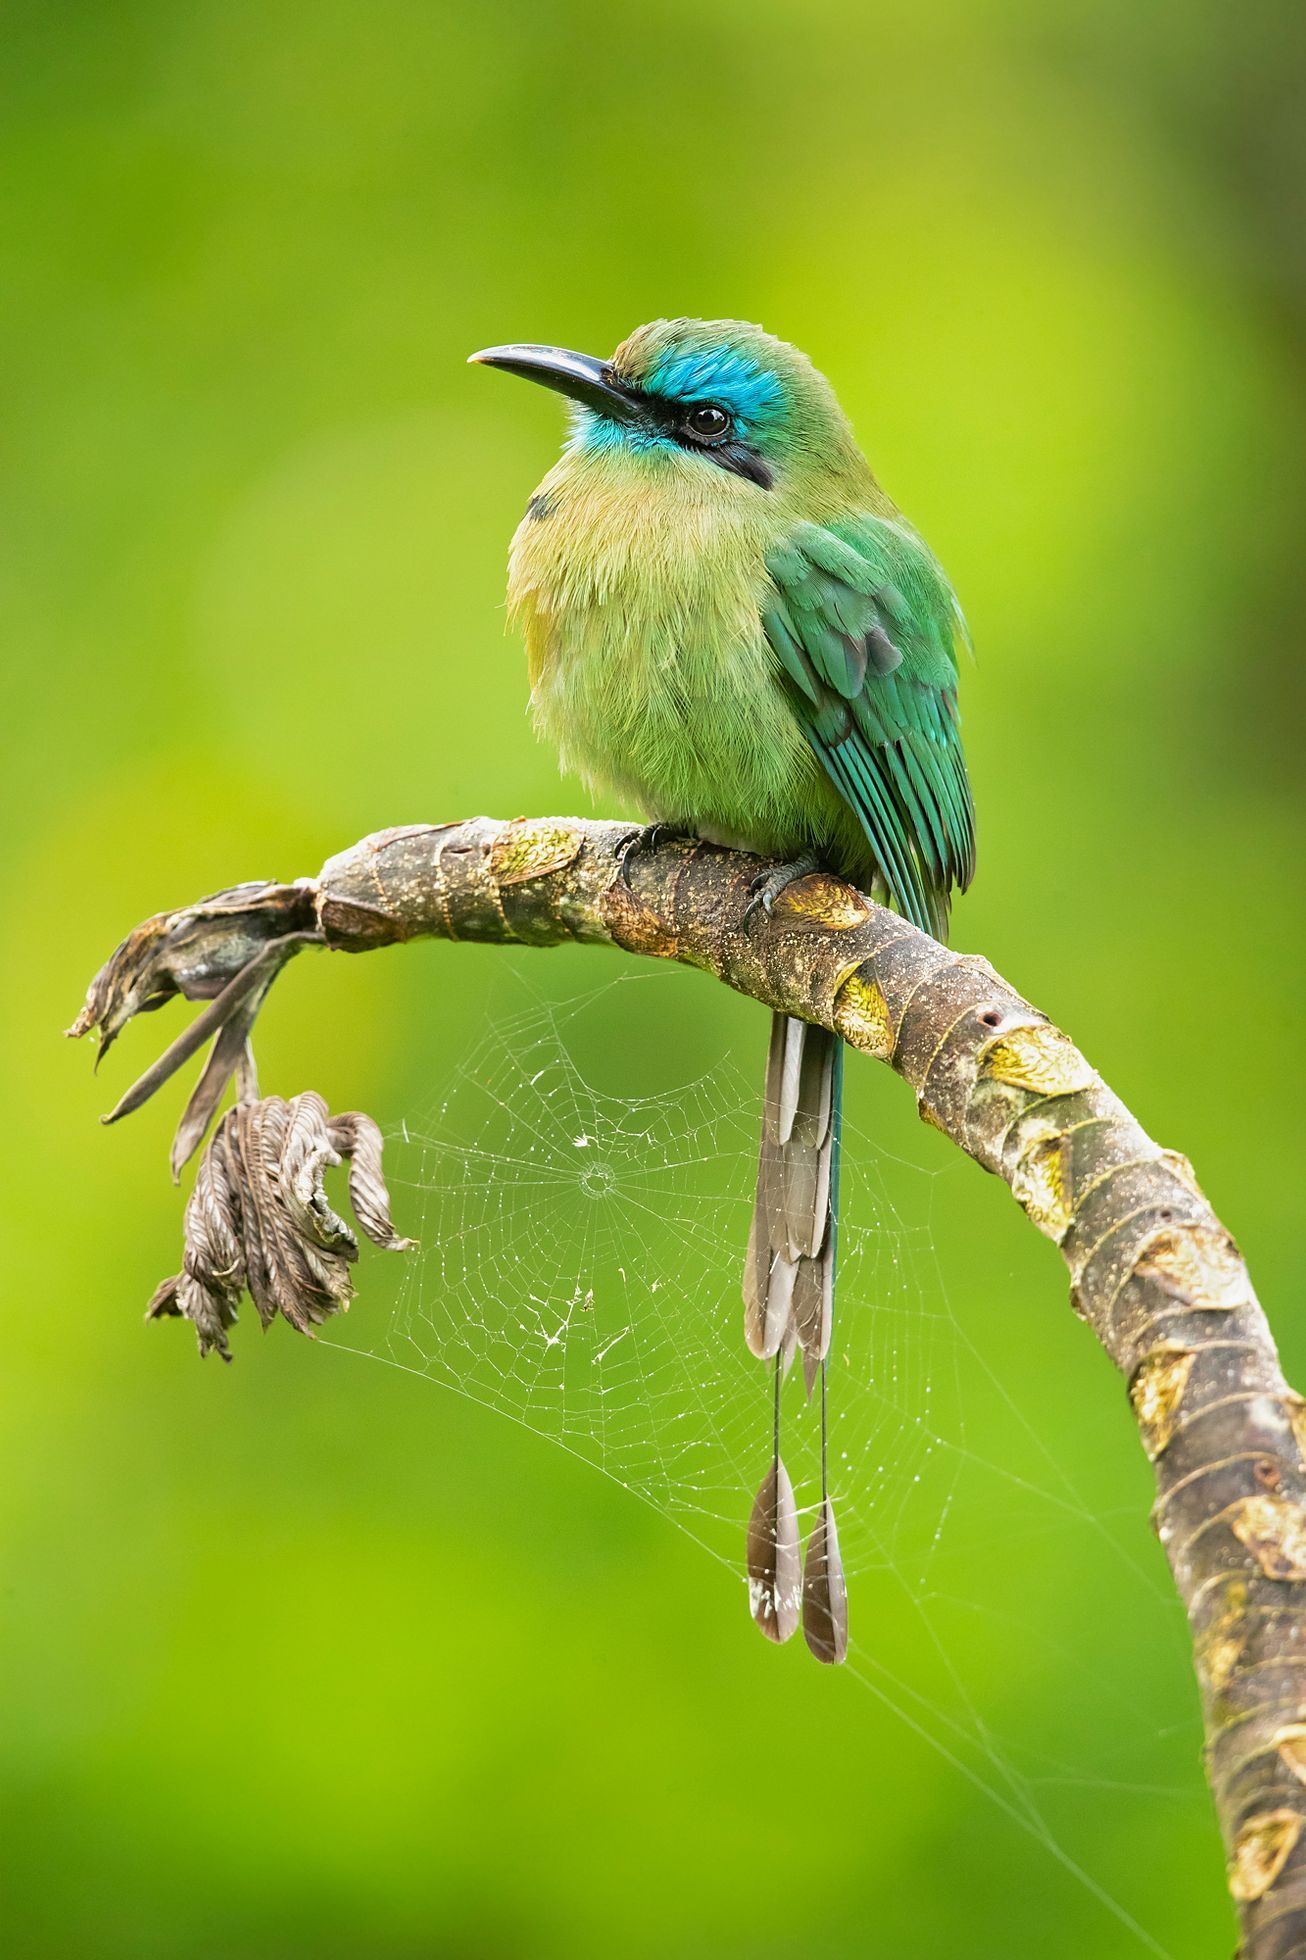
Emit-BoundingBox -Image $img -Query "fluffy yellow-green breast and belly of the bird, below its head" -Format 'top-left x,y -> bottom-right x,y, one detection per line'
508,472 -> 816,845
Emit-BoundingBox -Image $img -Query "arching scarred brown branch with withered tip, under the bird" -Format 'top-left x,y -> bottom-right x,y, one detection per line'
71,817 -> 1306,1960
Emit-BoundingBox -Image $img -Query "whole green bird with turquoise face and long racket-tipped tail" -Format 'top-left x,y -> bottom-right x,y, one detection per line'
471,318 -> 975,1662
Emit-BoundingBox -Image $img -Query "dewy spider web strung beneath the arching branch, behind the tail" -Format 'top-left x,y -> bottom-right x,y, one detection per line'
326,956 -> 1204,1954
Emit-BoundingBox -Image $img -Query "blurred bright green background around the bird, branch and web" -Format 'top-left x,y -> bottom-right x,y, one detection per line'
0,0 -> 1306,1960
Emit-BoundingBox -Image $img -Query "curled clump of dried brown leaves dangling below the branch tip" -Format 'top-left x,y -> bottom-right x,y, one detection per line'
147,1092 -> 412,1360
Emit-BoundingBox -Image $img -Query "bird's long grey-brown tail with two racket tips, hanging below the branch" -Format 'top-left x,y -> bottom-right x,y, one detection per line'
743,1013 -> 847,1660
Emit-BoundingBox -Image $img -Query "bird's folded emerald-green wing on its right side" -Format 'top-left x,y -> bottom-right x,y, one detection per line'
763,515 -> 975,937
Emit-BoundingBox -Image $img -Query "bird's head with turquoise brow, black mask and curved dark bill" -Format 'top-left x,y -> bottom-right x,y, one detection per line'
471,319 -> 865,492
